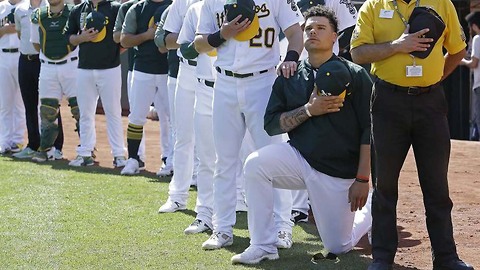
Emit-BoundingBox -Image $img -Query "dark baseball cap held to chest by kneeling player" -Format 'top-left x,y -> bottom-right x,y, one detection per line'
315,60 -> 352,98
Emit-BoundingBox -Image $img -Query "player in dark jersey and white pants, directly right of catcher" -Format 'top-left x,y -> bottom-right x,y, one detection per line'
64,0 -> 126,167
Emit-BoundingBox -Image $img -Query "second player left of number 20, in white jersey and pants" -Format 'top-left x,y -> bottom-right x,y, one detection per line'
158,0 -> 198,213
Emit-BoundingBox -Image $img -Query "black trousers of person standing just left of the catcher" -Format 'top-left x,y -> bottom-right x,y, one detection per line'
18,54 -> 64,150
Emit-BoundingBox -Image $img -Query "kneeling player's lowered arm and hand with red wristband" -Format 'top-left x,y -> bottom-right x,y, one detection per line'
348,144 -> 370,212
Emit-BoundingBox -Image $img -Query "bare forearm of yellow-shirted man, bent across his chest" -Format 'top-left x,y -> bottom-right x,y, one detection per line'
350,42 -> 397,64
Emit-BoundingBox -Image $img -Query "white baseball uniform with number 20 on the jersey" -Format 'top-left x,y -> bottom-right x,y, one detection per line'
197,0 -> 303,237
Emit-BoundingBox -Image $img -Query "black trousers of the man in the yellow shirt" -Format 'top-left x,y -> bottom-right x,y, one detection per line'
371,79 -> 458,263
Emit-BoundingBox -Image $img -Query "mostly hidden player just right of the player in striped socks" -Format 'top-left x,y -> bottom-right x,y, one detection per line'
153,6 -> 180,177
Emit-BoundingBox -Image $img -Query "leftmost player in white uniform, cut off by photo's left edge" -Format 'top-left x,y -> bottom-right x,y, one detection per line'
0,0 -> 26,154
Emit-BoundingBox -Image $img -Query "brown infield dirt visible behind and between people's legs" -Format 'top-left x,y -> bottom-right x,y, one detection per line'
58,104 -> 480,269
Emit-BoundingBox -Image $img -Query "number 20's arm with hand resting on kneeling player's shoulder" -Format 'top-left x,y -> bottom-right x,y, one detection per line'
277,23 -> 303,78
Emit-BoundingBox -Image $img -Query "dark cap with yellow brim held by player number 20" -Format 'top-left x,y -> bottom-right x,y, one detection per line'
224,0 -> 260,41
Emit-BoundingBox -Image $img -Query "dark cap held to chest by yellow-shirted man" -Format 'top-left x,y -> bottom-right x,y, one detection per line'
408,7 -> 445,59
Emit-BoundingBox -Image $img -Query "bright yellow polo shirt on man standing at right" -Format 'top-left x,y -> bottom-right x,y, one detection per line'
350,0 -> 466,86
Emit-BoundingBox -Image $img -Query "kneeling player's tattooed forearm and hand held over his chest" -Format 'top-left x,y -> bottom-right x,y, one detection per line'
280,87 -> 344,132
